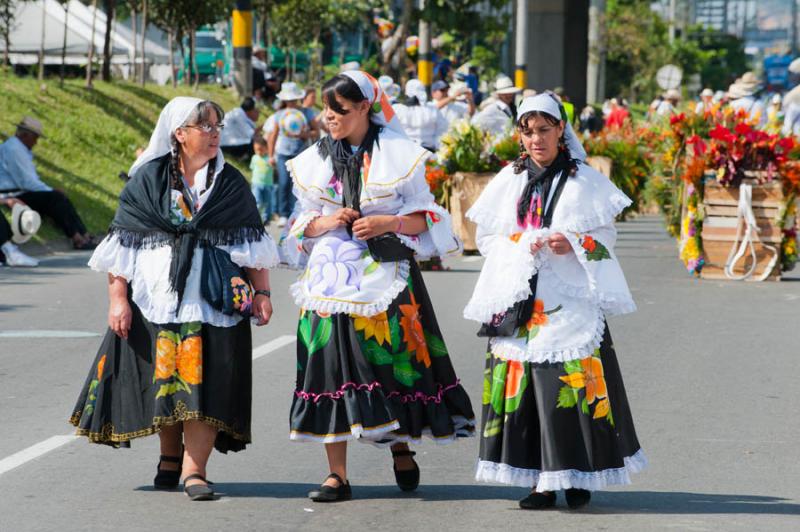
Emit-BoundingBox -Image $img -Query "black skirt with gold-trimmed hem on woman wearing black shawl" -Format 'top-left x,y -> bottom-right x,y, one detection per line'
70,302 -> 252,453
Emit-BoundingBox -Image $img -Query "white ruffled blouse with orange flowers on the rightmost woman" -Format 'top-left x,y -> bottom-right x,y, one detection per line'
464,164 -> 636,362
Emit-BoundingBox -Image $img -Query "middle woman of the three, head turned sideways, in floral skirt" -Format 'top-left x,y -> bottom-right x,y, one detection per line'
281,71 -> 475,502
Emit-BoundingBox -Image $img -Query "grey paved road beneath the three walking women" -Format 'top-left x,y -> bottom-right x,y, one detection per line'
0,218 -> 800,532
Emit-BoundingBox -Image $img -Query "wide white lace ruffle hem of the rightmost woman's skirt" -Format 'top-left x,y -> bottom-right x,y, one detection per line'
475,449 -> 647,491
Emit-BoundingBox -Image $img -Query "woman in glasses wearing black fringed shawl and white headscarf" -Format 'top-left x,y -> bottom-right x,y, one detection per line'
70,97 -> 278,500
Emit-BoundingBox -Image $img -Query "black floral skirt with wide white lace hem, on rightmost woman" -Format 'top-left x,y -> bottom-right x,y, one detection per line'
476,326 -> 647,491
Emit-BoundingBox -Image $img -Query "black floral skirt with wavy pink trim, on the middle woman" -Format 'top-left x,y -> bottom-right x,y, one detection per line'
290,261 -> 475,445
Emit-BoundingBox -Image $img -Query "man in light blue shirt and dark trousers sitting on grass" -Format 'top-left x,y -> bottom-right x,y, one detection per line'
0,116 -> 97,249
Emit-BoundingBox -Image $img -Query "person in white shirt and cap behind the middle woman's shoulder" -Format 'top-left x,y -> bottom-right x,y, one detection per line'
392,79 -> 448,151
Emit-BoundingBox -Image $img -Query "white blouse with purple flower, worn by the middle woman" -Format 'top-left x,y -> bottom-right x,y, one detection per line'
279,129 -> 461,316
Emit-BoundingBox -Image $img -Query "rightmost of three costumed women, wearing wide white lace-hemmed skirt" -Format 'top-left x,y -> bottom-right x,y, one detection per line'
464,94 -> 646,509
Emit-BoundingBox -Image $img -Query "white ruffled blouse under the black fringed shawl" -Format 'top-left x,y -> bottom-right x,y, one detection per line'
89,169 -> 278,327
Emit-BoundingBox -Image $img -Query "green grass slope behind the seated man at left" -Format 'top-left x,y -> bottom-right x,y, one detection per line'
0,71 -> 249,242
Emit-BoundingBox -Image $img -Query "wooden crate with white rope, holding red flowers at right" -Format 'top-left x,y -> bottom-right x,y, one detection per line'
700,181 -> 784,281
